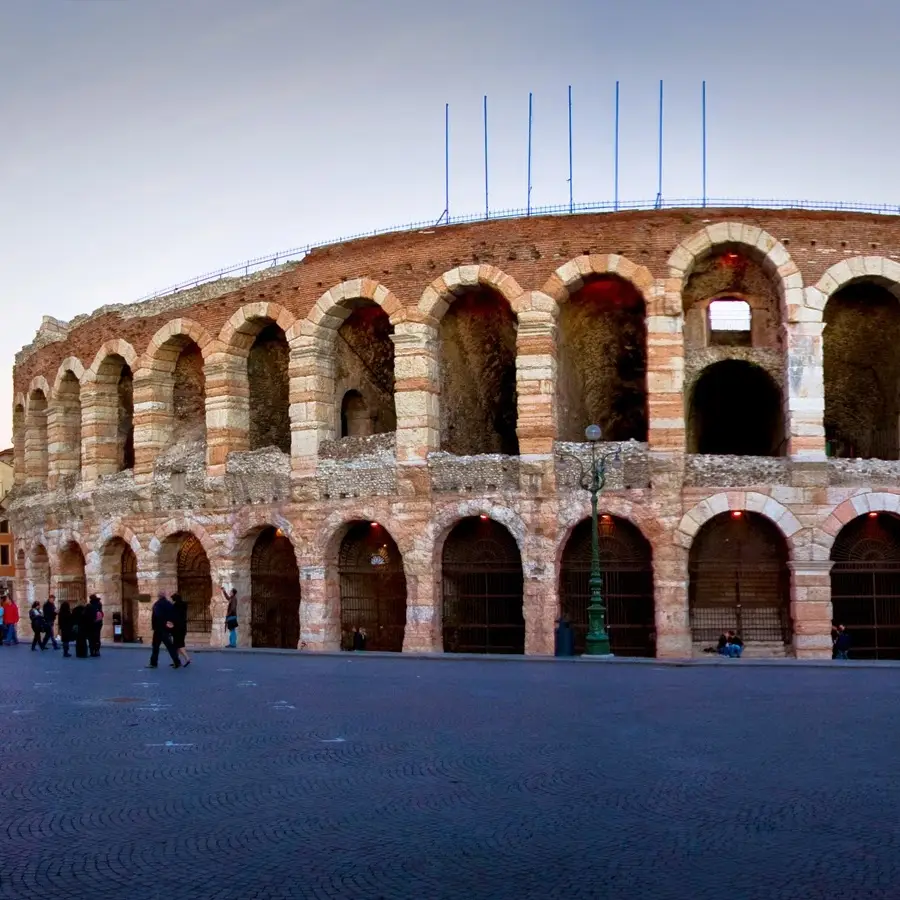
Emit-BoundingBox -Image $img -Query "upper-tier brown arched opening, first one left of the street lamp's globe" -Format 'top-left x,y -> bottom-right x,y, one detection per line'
440,288 -> 519,456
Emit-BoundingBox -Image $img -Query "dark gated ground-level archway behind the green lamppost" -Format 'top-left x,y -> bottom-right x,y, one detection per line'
559,515 -> 656,656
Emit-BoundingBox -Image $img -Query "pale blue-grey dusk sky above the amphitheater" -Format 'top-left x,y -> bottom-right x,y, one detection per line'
0,0 -> 900,446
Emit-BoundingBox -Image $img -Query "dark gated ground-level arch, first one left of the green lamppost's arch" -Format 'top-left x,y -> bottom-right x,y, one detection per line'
441,516 -> 525,653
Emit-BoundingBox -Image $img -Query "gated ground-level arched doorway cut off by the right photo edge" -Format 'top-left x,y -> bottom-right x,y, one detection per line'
831,513 -> 900,659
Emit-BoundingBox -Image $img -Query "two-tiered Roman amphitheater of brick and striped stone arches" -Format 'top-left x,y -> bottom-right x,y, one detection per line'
10,209 -> 900,658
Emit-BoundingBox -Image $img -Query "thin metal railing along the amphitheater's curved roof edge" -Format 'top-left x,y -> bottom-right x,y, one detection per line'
137,197 -> 900,303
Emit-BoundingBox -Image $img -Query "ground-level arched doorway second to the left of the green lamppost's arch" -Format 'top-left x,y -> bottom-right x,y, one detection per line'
338,522 -> 406,653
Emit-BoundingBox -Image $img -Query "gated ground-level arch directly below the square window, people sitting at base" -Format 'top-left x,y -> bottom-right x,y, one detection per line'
689,510 -> 791,645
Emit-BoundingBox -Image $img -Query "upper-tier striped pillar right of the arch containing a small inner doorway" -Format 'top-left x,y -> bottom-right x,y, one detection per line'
391,310 -> 441,463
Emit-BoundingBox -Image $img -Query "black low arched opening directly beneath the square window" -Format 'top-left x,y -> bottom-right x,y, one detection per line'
688,359 -> 785,456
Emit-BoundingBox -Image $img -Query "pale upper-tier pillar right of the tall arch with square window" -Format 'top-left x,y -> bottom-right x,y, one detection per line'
783,318 -> 831,460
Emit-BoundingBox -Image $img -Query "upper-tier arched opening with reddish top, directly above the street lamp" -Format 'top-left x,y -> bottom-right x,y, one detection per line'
559,276 -> 647,441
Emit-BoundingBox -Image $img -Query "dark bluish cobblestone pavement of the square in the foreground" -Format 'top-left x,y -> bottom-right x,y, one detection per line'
0,646 -> 900,900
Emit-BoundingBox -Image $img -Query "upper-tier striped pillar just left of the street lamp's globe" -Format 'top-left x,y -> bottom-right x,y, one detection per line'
516,293 -> 557,456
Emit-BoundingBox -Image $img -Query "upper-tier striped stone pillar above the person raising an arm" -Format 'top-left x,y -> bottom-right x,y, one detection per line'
204,348 -> 250,477
